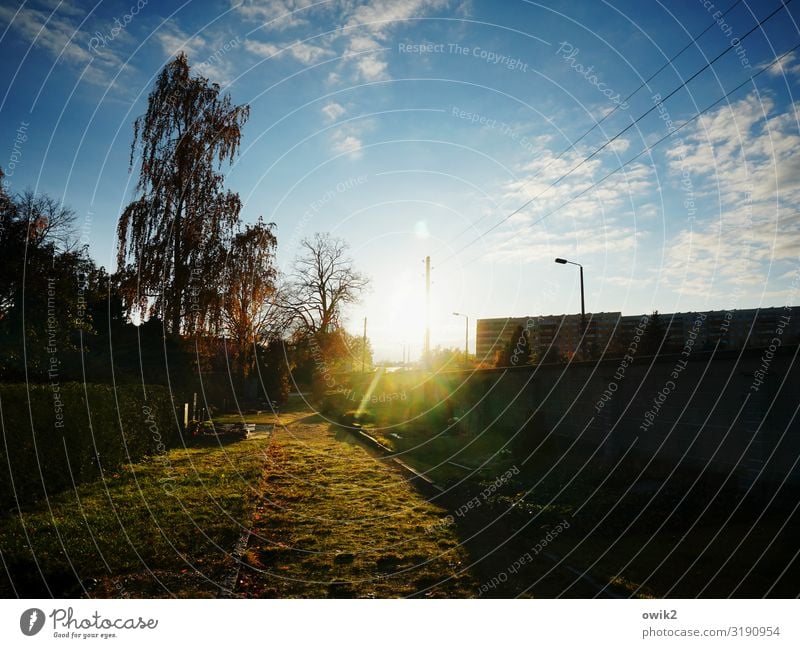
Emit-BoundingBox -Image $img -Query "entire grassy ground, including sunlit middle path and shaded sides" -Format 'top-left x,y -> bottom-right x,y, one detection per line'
0,394 -> 800,598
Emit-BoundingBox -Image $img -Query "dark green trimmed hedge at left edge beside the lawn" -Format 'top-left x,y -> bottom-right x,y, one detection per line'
0,383 -> 181,510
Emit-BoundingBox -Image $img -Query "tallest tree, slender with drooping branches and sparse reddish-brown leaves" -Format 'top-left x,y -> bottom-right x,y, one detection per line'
117,53 -> 249,335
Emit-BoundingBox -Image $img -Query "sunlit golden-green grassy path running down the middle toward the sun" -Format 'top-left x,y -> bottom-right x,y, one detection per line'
236,417 -> 478,598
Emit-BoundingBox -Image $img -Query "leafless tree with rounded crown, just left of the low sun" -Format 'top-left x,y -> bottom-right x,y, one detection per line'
286,233 -> 369,337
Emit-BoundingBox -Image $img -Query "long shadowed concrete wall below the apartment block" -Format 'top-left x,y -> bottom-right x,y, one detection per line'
355,346 -> 800,485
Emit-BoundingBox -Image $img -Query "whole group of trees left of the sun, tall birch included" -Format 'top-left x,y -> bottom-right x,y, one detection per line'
0,54 -> 372,410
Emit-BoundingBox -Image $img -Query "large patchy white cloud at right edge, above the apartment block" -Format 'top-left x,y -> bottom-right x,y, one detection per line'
663,94 -> 800,294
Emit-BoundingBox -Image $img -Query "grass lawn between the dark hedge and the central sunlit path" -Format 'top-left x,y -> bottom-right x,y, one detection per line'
0,438 -> 269,597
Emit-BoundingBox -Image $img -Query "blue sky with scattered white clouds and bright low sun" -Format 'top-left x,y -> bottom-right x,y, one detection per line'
0,0 -> 800,359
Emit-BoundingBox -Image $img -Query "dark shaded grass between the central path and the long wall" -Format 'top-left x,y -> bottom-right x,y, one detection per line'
354,423 -> 800,598
